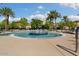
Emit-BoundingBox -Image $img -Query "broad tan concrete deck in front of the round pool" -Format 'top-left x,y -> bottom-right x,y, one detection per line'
0,34 -> 79,56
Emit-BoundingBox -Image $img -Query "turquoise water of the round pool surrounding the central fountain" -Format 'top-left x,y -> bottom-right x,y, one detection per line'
13,32 -> 62,39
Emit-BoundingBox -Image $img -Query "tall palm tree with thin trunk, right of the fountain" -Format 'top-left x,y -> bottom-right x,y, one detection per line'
47,10 -> 61,30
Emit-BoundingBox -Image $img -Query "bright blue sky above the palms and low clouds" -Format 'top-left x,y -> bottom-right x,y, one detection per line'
0,3 -> 79,21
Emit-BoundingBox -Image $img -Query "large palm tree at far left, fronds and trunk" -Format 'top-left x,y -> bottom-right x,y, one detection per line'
0,7 -> 14,30
